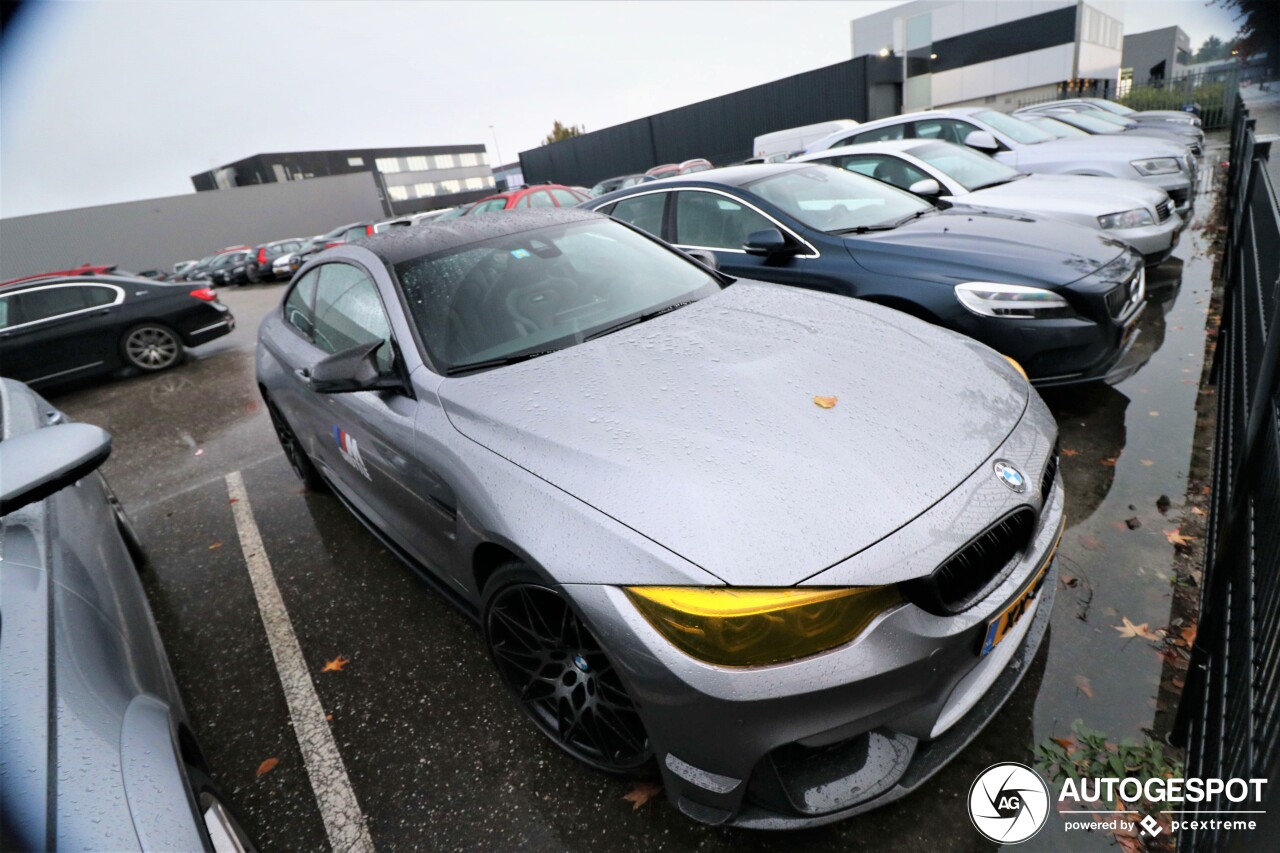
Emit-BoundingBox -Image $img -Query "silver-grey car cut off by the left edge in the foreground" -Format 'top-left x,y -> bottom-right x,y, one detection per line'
0,379 -> 253,853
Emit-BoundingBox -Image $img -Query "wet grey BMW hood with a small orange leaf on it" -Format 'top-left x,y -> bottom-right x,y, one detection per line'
439,280 -> 1028,585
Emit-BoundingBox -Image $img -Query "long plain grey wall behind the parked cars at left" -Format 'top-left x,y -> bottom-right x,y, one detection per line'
0,172 -> 384,280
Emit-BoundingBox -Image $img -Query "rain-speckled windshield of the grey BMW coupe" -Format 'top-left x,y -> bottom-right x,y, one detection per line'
396,220 -> 719,373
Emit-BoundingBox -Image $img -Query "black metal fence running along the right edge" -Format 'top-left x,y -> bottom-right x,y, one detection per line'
1175,89 -> 1280,852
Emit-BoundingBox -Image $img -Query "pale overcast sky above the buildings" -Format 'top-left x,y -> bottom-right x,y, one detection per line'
0,0 -> 1235,216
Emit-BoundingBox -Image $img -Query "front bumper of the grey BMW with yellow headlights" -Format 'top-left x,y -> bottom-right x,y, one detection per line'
564,404 -> 1064,829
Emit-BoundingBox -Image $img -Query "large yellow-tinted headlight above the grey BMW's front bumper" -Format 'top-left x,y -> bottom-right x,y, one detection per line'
625,587 -> 902,666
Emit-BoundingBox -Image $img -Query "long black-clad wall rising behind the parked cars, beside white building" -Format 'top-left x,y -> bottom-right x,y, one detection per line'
520,56 -> 901,187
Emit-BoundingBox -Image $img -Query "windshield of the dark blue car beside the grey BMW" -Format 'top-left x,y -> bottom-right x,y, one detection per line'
745,165 -> 933,233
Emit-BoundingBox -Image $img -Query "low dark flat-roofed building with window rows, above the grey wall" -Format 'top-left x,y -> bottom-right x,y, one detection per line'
191,145 -> 494,216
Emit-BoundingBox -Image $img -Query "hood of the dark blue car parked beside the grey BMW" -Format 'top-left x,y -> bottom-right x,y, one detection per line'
845,206 -> 1128,287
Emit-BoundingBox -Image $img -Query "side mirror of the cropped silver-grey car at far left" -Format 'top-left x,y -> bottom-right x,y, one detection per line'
0,424 -> 111,515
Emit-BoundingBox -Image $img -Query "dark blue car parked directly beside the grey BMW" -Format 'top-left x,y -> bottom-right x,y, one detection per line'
581,163 -> 1146,386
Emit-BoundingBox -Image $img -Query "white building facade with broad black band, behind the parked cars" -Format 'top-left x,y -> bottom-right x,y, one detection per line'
851,0 -> 1124,111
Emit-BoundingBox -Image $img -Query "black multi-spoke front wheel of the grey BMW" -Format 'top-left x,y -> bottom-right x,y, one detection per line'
484,564 -> 653,776
